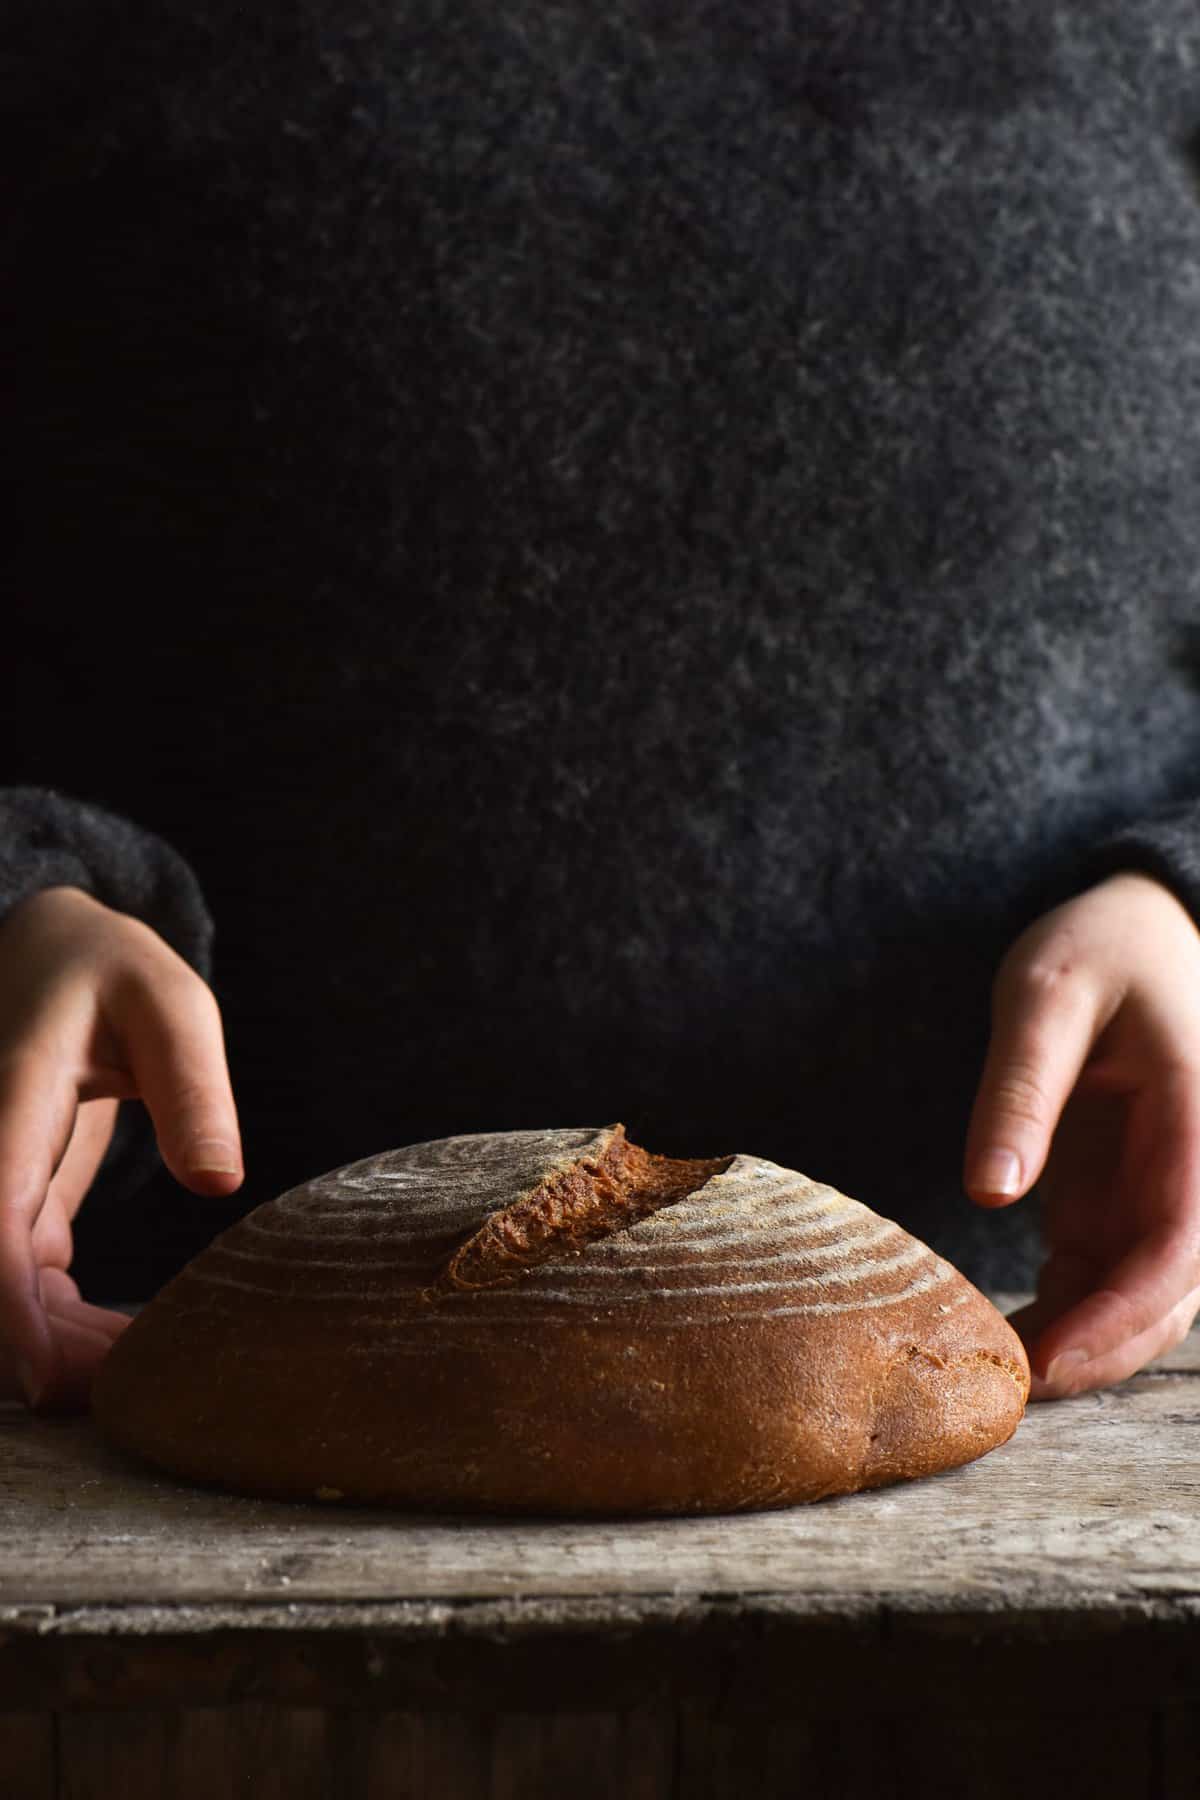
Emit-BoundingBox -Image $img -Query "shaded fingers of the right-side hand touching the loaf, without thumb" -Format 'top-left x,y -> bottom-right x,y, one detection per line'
1029,1073 -> 1200,1390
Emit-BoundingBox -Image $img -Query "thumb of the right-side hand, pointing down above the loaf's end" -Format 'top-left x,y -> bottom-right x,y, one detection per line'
963,961 -> 1101,1206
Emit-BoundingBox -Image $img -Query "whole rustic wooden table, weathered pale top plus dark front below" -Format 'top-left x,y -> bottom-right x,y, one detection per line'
0,1301 -> 1200,1800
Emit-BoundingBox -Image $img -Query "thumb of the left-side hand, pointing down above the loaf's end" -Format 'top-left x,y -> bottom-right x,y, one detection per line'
104,970 -> 243,1195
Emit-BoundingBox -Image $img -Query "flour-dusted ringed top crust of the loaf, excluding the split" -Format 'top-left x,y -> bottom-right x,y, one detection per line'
180,1129 -> 966,1339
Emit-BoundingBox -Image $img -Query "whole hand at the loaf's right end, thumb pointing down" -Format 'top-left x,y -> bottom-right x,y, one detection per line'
964,873 -> 1200,1400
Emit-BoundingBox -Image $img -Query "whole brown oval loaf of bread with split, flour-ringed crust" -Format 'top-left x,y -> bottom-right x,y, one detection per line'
94,1125 -> 1029,1516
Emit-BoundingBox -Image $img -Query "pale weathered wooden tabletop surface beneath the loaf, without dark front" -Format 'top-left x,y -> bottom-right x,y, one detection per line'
0,1288 -> 1200,1631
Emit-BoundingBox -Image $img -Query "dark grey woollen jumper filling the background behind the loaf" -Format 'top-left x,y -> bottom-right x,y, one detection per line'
0,0 -> 1200,1294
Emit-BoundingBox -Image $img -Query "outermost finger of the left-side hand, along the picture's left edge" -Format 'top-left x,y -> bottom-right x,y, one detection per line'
0,1053 -> 86,1388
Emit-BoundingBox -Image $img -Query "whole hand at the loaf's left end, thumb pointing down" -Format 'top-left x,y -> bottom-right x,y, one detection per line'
0,887 -> 243,1409
